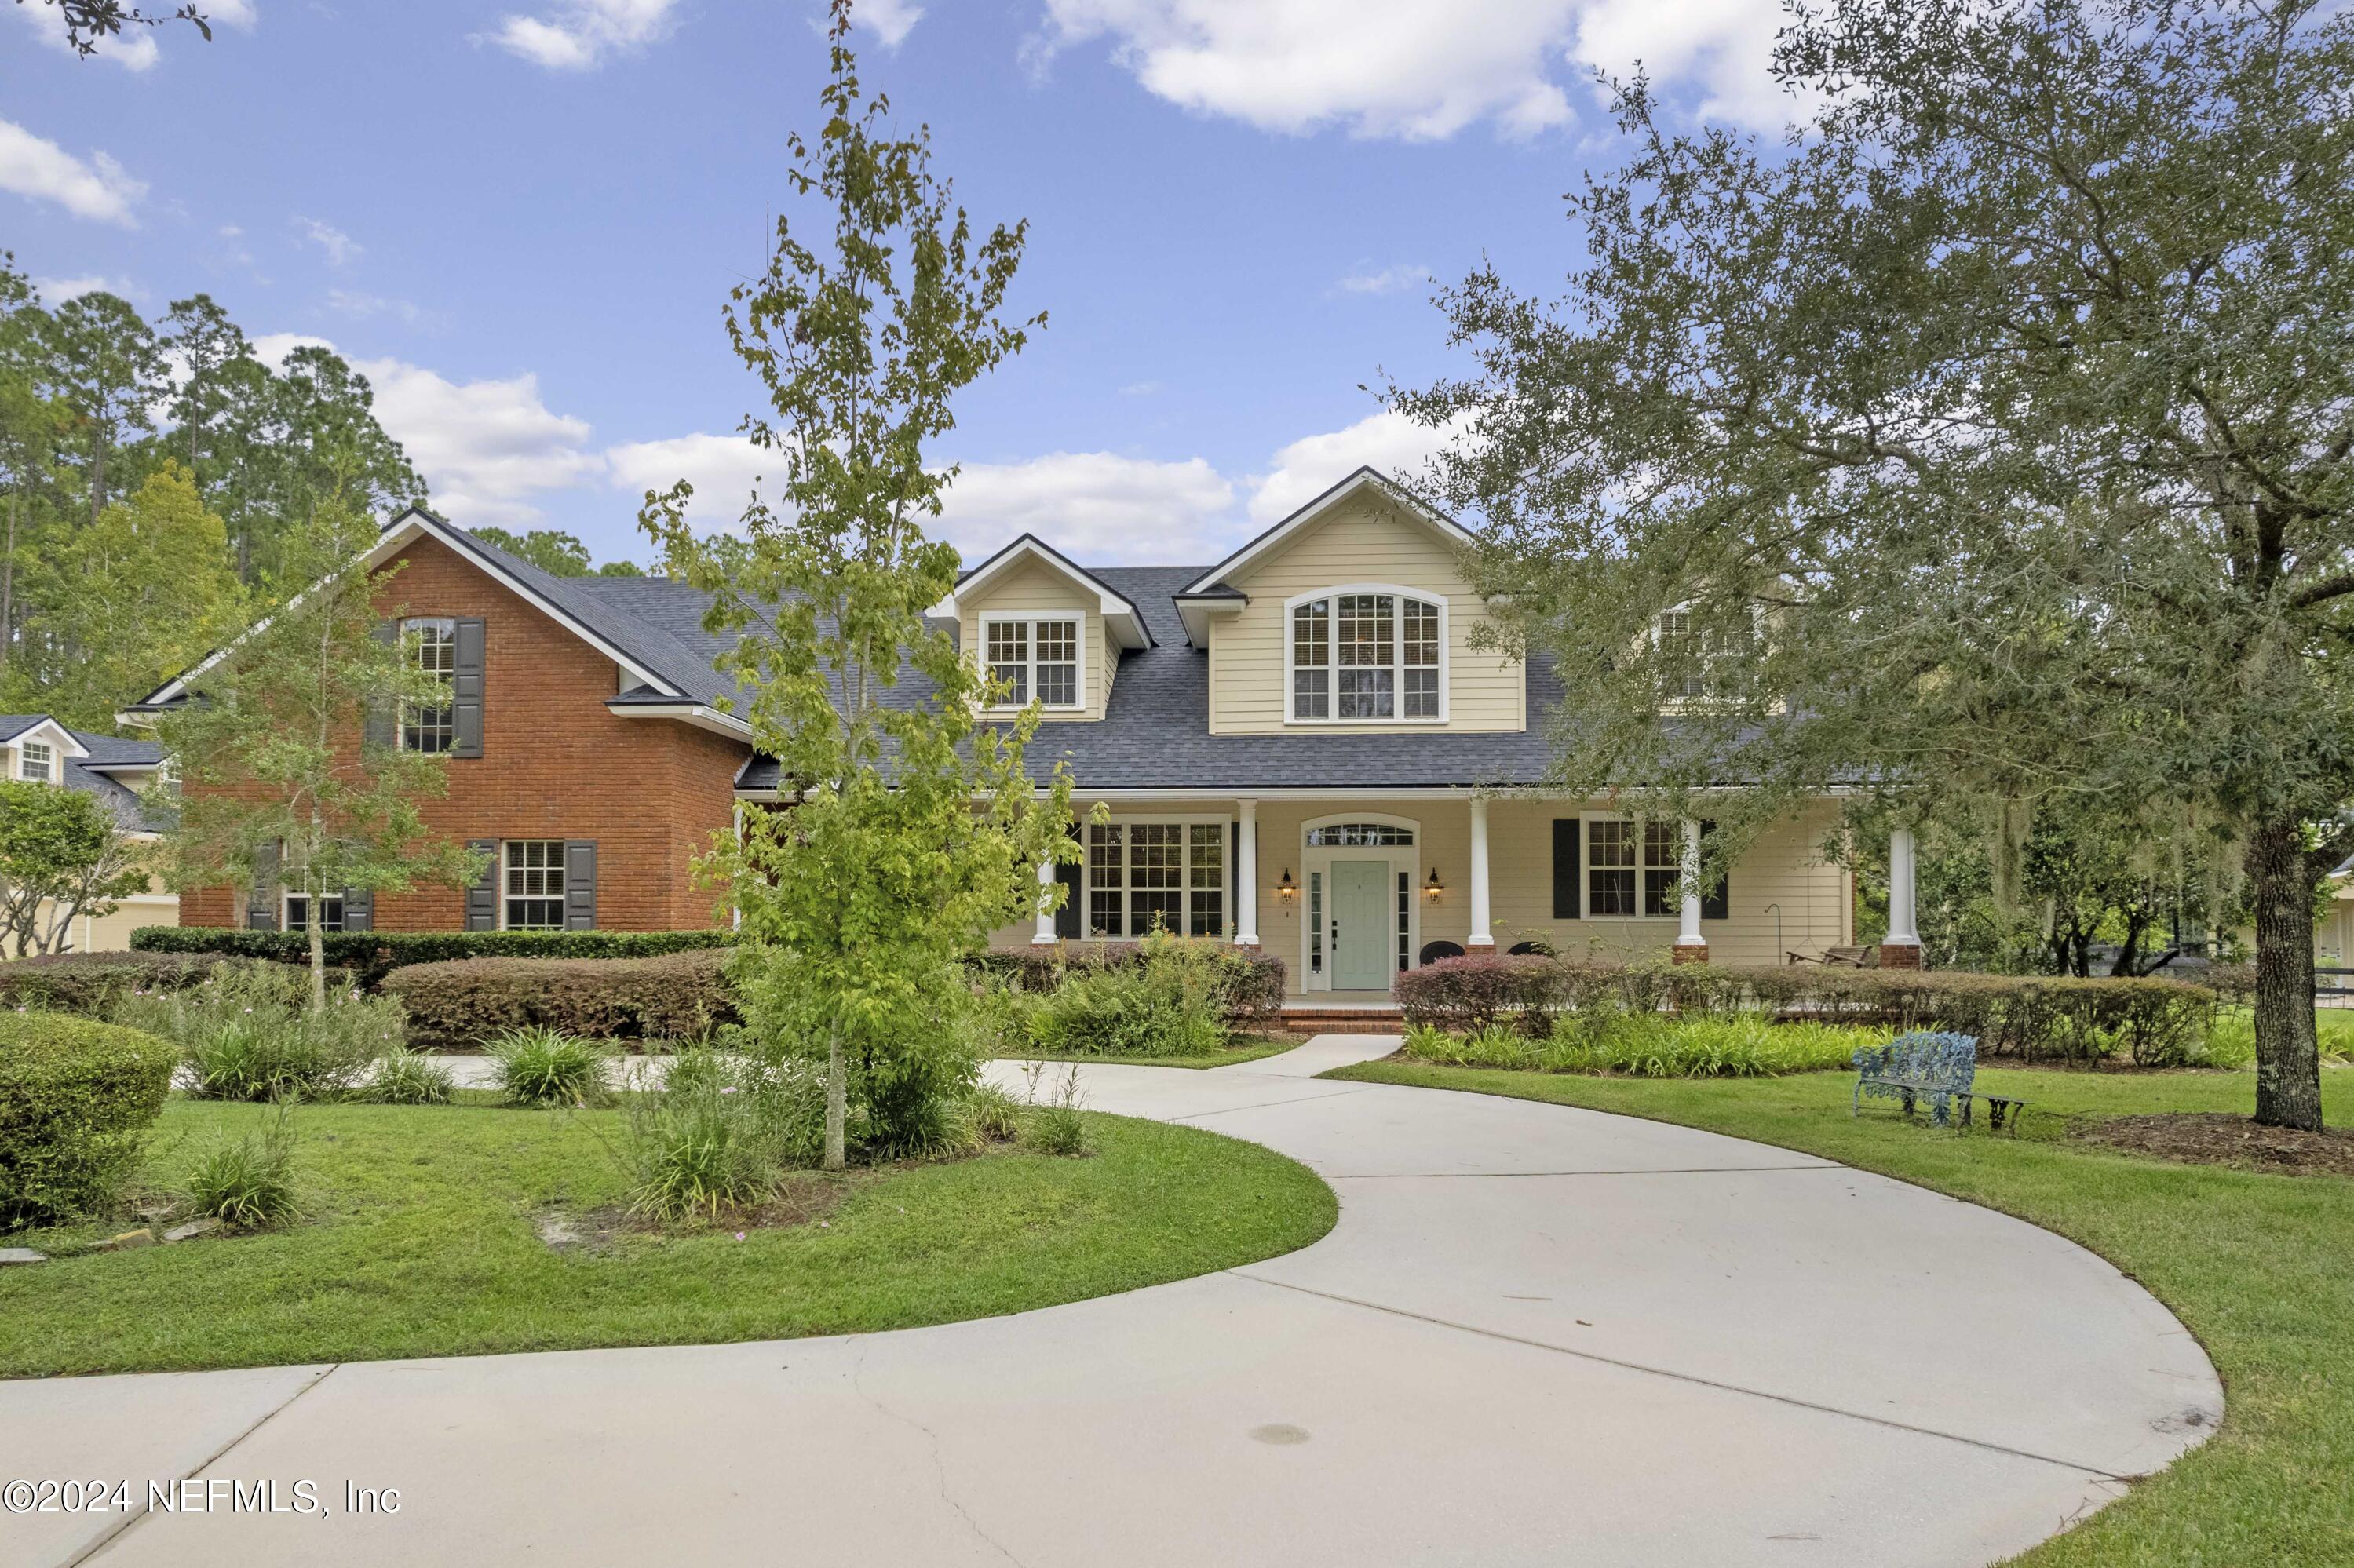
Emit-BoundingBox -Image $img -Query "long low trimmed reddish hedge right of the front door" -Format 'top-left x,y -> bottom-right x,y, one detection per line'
1396,958 -> 2215,1067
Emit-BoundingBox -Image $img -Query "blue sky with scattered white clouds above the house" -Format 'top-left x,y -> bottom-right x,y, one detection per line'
0,0 -> 1782,563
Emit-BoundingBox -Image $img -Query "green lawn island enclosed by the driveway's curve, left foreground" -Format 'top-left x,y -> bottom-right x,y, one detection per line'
0,1099 -> 1334,1377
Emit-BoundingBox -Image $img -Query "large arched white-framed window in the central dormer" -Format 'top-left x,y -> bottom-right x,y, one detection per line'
1290,589 -> 1445,723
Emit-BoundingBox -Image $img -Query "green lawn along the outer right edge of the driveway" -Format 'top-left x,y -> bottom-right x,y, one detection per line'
1325,1059 -> 2354,1568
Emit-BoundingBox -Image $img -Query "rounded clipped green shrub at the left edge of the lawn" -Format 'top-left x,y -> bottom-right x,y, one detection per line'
0,1012 -> 177,1229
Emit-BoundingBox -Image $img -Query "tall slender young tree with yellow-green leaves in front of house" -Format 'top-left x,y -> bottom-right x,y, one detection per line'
641,0 -> 1078,1170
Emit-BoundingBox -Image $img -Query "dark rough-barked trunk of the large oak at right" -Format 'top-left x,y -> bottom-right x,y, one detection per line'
2248,817 -> 2321,1132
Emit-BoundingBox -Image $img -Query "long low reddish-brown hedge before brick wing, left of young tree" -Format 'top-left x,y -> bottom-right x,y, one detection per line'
384,951 -> 739,1048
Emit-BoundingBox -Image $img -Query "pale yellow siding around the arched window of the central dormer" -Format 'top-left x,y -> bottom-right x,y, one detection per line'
1210,497 -> 1527,735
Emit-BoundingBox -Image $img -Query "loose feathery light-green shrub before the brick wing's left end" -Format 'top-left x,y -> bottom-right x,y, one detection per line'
115,965 -> 403,1099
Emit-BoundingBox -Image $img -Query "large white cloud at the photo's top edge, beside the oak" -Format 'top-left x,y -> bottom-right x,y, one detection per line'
1027,0 -> 1789,141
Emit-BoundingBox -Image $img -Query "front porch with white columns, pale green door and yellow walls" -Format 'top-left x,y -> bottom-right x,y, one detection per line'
996,789 -> 1909,994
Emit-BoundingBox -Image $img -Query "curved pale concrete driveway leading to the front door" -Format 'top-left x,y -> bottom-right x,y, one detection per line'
0,1036 -> 2222,1568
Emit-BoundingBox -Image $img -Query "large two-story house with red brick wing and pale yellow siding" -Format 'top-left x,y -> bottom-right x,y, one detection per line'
132,469 -> 1918,998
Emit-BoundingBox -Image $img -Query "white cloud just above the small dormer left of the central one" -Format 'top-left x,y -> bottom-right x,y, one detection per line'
942,452 -> 1233,565
